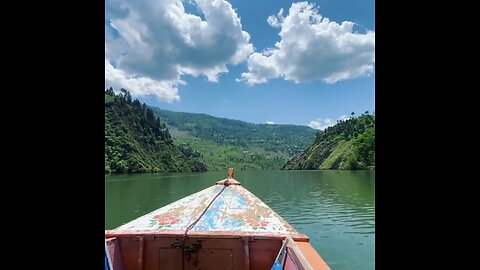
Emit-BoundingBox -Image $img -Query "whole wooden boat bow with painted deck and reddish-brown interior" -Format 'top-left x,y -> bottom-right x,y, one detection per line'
105,170 -> 330,270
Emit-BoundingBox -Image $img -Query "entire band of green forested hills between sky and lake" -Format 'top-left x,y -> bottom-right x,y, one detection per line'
105,88 -> 375,173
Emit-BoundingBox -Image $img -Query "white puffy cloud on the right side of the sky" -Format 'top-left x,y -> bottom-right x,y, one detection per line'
241,2 -> 375,85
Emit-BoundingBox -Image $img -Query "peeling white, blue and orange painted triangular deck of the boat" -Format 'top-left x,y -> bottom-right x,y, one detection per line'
115,182 -> 298,236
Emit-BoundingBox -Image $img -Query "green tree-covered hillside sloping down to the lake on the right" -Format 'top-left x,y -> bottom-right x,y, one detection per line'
283,112 -> 375,170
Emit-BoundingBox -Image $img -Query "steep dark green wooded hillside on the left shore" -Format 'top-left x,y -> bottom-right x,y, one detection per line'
105,88 -> 206,173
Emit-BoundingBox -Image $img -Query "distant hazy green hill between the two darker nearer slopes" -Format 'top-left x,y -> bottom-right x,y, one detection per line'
152,108 -> 317,170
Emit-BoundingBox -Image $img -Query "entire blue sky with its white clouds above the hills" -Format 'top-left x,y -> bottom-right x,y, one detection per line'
105,0 -> 375,129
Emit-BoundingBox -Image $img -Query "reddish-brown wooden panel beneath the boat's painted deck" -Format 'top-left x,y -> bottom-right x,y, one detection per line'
107,234 -> 282,270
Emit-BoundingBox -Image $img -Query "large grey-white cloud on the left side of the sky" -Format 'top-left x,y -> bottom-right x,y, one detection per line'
105,0 -> 253,102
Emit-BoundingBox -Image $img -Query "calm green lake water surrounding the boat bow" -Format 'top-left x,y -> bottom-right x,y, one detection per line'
105,170 -> 375,270
